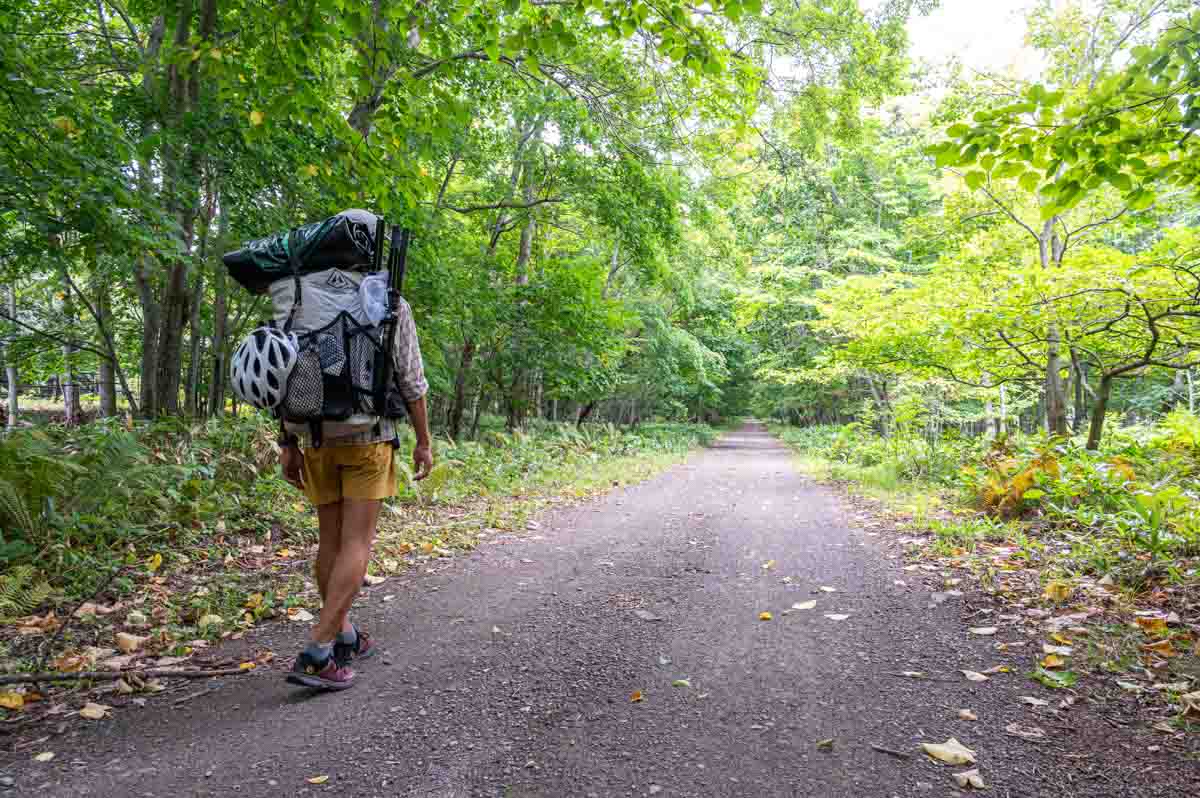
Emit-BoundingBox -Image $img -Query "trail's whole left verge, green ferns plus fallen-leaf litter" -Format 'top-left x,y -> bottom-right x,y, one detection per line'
0,414 -> 714,712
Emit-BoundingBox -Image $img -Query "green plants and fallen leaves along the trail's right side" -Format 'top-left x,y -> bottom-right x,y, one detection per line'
775,402 -> 1200,732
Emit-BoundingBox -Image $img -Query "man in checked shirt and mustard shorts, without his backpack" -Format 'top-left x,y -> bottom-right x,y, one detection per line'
280,300 -> 433,690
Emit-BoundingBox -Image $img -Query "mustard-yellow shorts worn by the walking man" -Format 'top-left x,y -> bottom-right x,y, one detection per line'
301,442 -> 396,506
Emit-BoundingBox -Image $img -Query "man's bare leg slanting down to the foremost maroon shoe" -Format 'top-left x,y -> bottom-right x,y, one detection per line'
312,499 -> 383,644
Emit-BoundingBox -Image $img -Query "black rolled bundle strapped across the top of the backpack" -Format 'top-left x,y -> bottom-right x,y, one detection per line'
221,208 -> 380,294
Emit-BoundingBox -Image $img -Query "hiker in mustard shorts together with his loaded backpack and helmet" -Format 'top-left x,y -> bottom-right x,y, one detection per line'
224,210 -> 433,690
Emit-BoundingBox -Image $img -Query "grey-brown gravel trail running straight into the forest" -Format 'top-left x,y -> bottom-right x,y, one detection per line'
0,426 -> 1200,798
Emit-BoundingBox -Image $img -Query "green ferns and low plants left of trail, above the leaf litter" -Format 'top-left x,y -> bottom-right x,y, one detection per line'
0,414 -> 713,607
